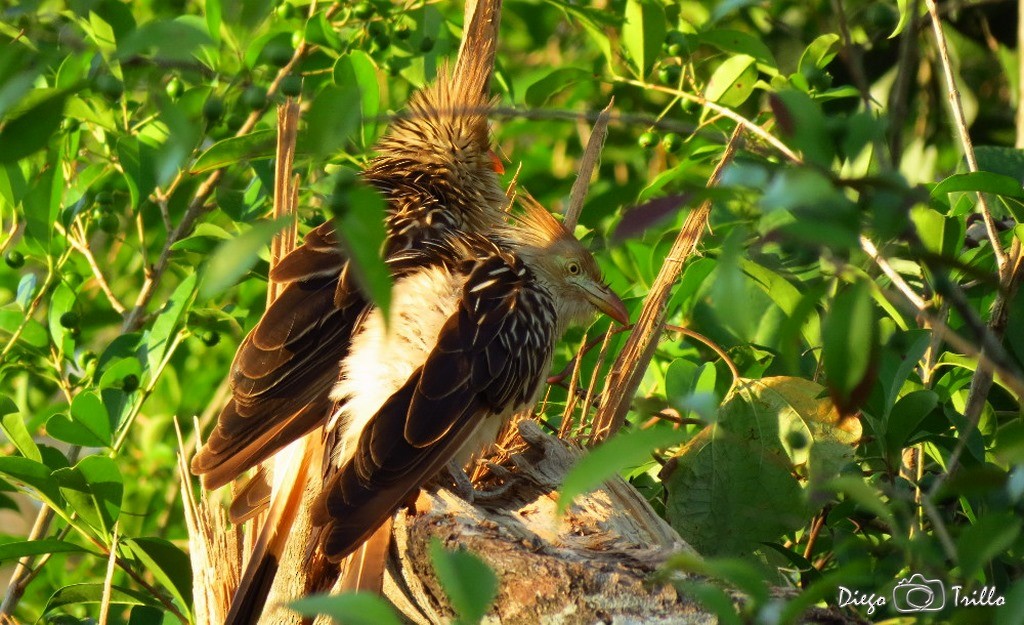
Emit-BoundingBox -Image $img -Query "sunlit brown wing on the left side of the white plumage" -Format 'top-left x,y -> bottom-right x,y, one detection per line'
191,222 -> 367,489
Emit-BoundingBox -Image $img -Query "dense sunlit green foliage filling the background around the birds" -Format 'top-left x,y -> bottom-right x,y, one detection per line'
0,0 -> 1024,624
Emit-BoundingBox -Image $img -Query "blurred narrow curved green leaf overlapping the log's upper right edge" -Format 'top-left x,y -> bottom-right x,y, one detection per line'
558,427 -> 687,512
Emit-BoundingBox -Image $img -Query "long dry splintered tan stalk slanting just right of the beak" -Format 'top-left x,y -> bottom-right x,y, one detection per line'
590,125 -> 743,445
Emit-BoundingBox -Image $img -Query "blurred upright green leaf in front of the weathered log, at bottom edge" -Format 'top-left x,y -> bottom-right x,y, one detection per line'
430,538 -> 498,625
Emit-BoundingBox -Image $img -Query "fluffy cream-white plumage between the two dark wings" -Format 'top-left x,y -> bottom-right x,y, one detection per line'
328,267 -> 466,466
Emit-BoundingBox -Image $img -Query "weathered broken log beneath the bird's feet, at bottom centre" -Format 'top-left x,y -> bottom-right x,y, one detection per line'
376,421 -> 716,625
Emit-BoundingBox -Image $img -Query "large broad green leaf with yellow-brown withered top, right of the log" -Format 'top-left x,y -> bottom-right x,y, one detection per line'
662,378 -> 831,555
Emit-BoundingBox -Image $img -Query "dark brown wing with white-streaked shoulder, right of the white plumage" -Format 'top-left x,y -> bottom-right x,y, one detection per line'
313,247 -> 555,560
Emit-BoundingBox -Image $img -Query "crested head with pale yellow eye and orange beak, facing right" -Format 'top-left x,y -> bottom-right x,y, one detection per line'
507,196 -> 630,331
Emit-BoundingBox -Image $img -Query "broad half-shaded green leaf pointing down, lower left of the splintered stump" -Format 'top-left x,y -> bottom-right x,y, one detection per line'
53,456 -> 124,538
